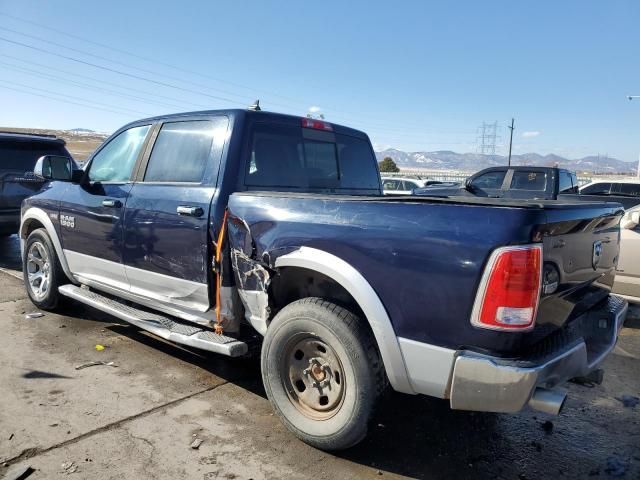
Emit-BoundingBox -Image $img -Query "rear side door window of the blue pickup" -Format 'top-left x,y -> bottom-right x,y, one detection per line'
144,117 -> 222,183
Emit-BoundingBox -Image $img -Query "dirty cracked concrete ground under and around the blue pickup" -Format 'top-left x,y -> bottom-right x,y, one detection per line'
0,237 -> 640,480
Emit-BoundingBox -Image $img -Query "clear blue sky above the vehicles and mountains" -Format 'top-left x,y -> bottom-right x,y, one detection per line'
0,0 -> 640,161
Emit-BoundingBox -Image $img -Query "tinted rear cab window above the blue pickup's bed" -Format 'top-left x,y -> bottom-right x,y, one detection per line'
244,122 -> 380,195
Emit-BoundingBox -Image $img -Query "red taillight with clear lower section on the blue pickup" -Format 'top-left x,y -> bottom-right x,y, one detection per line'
471,245 -> 542,331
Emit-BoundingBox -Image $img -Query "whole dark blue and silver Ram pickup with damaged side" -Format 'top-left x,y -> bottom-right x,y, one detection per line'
20,110 -> 627,449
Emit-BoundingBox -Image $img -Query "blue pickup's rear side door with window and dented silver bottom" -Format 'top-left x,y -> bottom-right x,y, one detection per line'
124,116 -> 228,312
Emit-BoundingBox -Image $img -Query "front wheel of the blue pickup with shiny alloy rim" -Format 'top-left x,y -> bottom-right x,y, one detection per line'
22,228 -> 66,310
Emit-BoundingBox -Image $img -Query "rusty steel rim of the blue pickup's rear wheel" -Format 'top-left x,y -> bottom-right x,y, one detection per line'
281,334 -> 345,420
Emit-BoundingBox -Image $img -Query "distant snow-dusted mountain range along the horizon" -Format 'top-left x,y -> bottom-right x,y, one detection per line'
376,148 -> 638,174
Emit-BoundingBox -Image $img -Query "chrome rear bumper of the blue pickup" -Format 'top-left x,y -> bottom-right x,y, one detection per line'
450,295 -> 627,412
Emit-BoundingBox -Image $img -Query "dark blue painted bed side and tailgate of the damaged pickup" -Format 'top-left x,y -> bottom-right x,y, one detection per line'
229,192 -> 623,356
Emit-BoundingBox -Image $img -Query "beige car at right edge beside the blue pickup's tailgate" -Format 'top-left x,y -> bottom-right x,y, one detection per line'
613,206 -> 640,303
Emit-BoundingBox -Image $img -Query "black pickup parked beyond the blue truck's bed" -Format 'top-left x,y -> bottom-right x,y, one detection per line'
414,166 -> 640,208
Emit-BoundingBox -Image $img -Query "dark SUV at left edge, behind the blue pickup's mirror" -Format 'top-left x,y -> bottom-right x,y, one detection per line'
0,132 -> 71,237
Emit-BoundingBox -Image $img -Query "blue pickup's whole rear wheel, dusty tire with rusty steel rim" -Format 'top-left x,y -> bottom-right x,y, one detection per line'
261,298 -> 387,450
